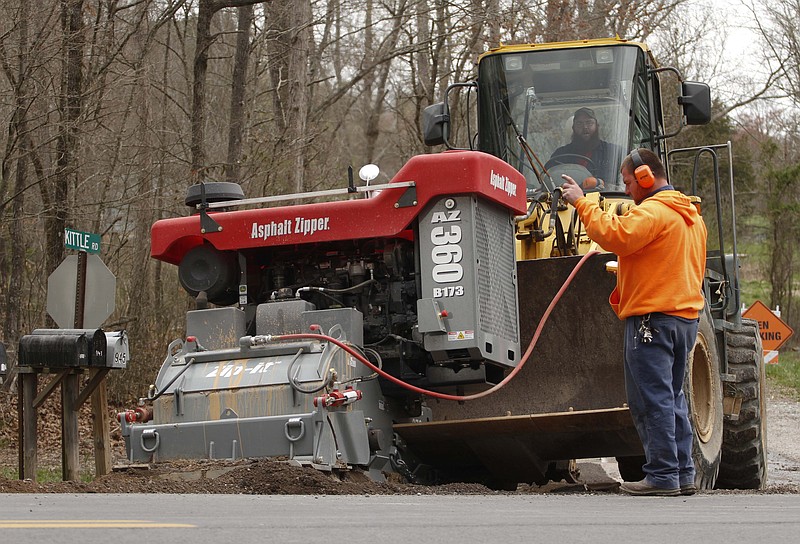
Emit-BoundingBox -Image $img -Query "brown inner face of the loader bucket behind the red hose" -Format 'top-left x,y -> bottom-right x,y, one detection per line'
427,254 -> 627,420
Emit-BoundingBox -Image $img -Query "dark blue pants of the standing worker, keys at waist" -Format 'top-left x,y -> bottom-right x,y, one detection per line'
625,313 -> 699,489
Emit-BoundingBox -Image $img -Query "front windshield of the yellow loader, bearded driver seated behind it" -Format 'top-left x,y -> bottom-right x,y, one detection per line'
478,46 -> 648,192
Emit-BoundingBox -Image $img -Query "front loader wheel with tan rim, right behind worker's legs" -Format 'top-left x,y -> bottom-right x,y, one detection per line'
683,311 -> 723,489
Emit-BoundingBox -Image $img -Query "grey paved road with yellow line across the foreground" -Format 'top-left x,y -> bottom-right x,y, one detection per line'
0,493 -> 800,544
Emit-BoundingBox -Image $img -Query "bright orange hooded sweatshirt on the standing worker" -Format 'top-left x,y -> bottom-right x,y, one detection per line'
575,188 -> 707,319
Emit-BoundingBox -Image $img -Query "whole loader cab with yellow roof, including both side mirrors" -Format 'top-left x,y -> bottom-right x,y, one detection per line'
423,38 -> 710,195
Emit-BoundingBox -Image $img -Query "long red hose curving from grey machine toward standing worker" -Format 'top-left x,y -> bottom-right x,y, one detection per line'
271,250 -> 600,402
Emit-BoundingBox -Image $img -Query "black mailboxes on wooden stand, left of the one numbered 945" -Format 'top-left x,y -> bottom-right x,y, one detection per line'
19,329 -> 107,368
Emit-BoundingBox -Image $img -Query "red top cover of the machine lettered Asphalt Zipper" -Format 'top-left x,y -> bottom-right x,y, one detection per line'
150,151 -> 526,264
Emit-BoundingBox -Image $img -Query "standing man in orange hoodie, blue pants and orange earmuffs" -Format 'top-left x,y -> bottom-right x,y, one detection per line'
562,149 -> 707,495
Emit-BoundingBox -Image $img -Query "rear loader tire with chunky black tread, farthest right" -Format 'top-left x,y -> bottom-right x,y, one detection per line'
717,319 -> 767,489
